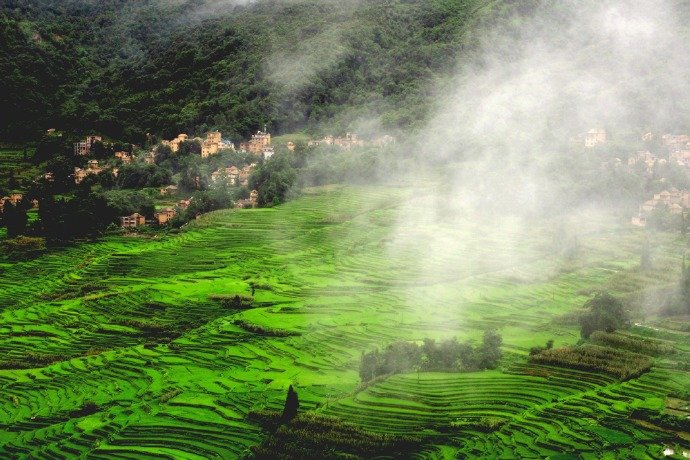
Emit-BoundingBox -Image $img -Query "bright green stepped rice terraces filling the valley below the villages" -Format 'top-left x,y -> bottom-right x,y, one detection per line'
0,187 -> 690,459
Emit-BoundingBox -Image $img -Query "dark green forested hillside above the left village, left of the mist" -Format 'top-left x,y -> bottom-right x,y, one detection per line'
0,0 -> 507,141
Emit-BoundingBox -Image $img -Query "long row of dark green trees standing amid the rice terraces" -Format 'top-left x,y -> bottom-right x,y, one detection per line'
359,330 -> 503,382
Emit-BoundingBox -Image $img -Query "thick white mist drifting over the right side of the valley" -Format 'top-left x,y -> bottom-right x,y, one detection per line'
389,1 -> 690,328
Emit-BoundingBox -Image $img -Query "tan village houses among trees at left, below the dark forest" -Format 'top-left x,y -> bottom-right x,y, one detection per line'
0,127 -> 395,231
